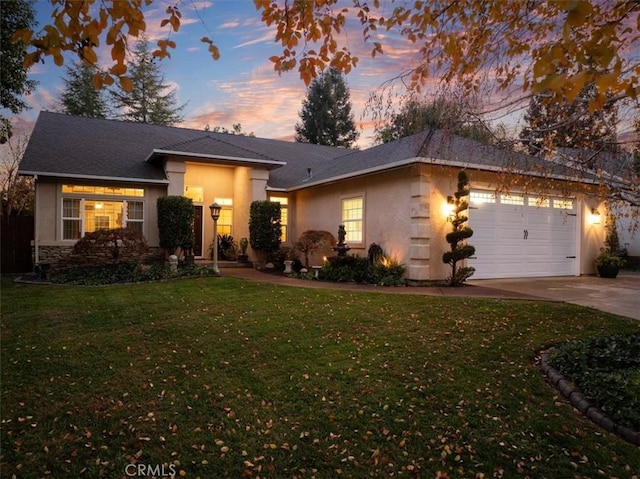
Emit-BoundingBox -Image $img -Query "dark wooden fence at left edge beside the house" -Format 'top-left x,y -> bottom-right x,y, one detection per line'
0,215 -> 34,274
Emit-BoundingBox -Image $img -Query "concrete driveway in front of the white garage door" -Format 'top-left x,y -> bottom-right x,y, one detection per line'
468,271 -> 640,320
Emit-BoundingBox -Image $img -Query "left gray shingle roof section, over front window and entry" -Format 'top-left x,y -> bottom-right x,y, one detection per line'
20,112 -> 345,187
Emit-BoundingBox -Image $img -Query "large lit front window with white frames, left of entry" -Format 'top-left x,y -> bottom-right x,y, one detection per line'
62,185 -> 144,240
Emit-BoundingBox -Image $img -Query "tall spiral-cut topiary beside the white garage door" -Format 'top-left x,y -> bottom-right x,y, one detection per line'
442,170 -> 476,286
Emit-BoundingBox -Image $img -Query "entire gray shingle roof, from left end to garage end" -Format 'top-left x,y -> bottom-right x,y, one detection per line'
20,112 -> 608,190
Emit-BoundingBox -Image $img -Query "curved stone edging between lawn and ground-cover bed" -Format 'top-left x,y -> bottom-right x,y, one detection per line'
540,348 -> 640,446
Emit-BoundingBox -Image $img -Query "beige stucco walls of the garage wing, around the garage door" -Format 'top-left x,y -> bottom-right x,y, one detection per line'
289,165 -> 606,284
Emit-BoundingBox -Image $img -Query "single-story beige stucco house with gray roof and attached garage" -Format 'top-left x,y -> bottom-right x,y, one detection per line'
19,112 -> 606,284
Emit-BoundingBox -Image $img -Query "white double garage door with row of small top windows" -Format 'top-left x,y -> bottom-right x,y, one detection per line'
468,190 -> 577,279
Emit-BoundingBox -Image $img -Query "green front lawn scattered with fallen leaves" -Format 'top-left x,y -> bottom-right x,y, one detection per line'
0,277 -> 640,479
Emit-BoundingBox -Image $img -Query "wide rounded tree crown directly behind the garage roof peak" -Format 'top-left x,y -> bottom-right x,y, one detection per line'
375,96 -> 495,143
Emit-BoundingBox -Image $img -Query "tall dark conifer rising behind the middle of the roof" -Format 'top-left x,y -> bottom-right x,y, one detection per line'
295,68 -> 359,148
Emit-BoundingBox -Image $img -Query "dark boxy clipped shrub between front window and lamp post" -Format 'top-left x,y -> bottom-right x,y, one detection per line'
157,196 -> 195,256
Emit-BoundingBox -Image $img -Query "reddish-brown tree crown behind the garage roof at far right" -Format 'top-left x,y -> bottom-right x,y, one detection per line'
520,87 -> 618,155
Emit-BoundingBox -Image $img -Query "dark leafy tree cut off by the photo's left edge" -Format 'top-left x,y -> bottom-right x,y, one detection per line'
0,0 -> 37,143
